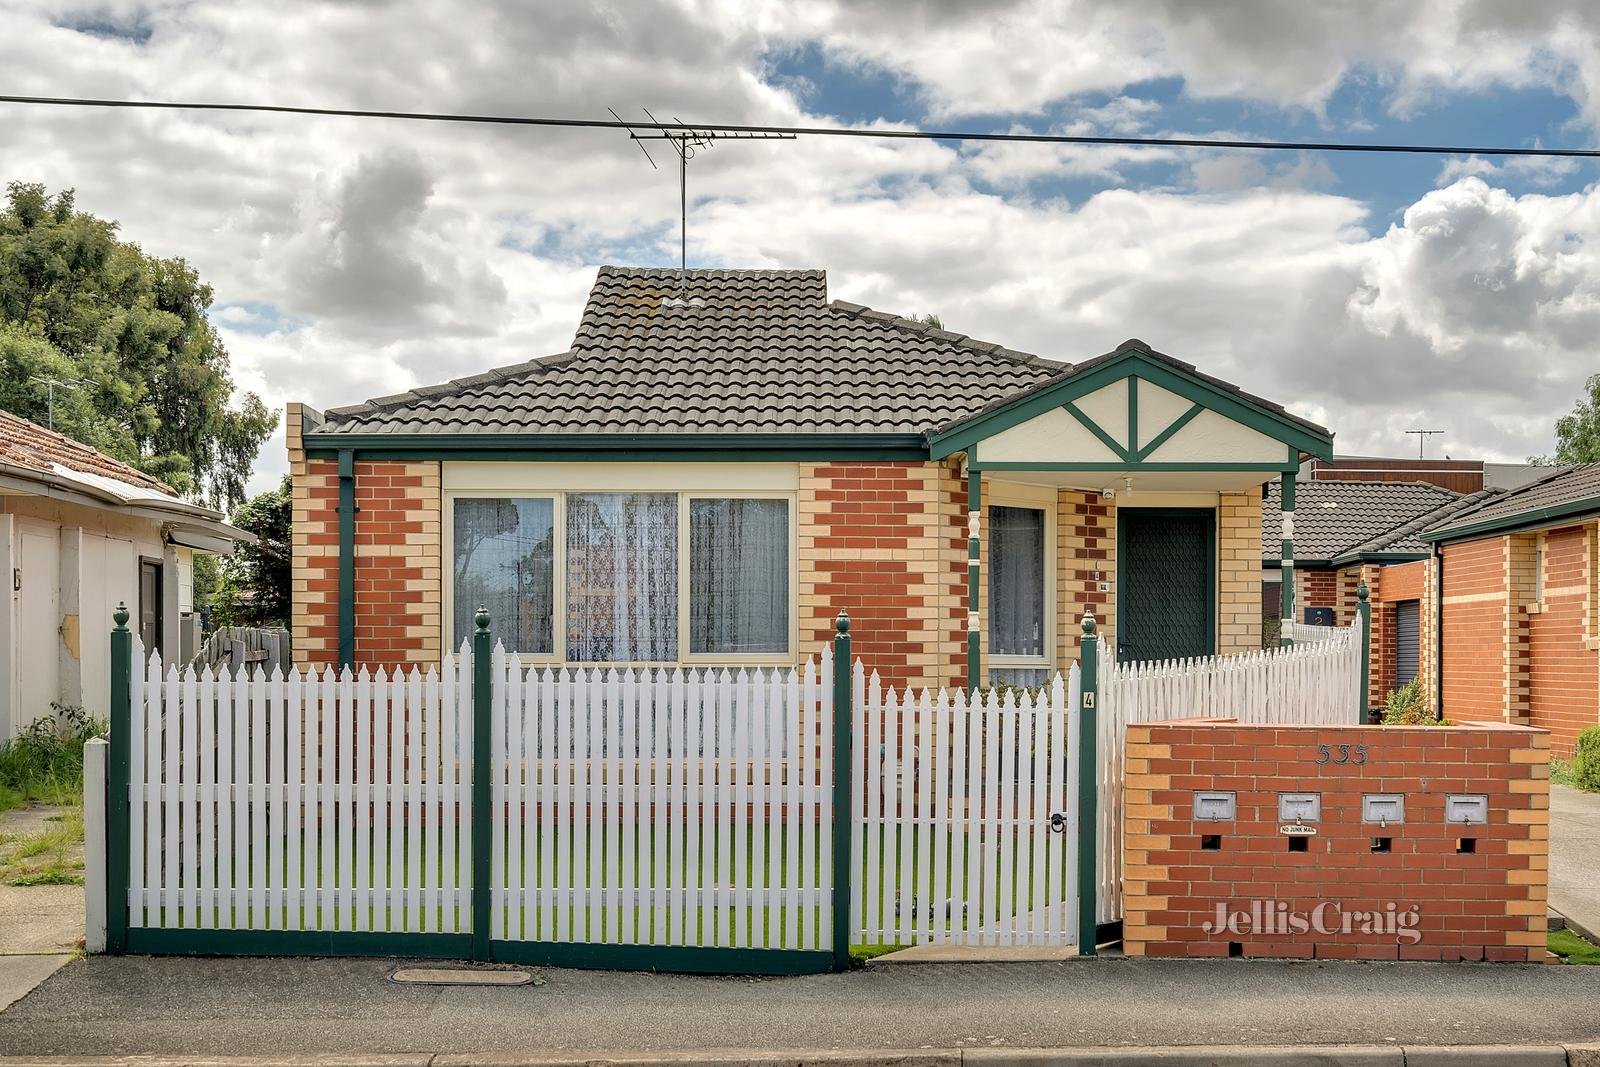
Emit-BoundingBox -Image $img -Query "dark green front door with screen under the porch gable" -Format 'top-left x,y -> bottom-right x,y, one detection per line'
1117,507 -> 1216,662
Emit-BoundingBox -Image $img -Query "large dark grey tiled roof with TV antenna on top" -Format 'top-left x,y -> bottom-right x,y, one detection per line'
320,267 -> 1069,434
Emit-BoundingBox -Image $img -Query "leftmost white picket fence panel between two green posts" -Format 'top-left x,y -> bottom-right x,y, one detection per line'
128,638 -> 472,933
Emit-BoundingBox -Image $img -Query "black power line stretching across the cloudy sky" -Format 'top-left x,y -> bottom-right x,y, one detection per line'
9,94 -> 1600,158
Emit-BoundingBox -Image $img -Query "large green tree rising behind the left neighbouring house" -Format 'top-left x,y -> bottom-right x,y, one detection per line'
0,182 -> 278,509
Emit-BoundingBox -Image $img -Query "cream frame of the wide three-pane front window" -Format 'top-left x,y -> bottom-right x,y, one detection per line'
440,483 -> 800,667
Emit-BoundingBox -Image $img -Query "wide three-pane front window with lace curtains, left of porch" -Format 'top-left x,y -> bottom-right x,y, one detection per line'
451,493 -> 794,664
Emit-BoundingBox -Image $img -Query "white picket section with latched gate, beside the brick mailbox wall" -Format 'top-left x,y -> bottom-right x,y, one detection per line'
851,662 -> 1078,945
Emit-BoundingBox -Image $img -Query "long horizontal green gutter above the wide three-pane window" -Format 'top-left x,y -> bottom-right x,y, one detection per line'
306,432 -> 928,462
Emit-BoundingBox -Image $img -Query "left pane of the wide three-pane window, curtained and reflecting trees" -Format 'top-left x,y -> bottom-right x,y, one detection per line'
451,498 -> 555,654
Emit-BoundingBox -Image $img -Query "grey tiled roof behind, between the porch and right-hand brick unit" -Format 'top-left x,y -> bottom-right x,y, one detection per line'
1261,480 -> 1462,561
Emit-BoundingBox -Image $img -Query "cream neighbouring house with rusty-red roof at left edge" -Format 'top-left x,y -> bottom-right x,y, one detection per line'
0,411 -> 251,741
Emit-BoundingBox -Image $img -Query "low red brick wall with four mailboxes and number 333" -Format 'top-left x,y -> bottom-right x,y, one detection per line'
1123,720 -> 1550,961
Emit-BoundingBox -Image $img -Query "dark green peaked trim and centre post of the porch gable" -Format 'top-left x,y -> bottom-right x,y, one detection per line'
928,350 -> 1333,459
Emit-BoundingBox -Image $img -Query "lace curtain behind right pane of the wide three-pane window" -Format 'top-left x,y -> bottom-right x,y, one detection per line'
690,499 -> 789,654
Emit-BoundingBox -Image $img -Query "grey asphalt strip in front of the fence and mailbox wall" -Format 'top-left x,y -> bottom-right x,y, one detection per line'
0,957 -> 1600,1056
